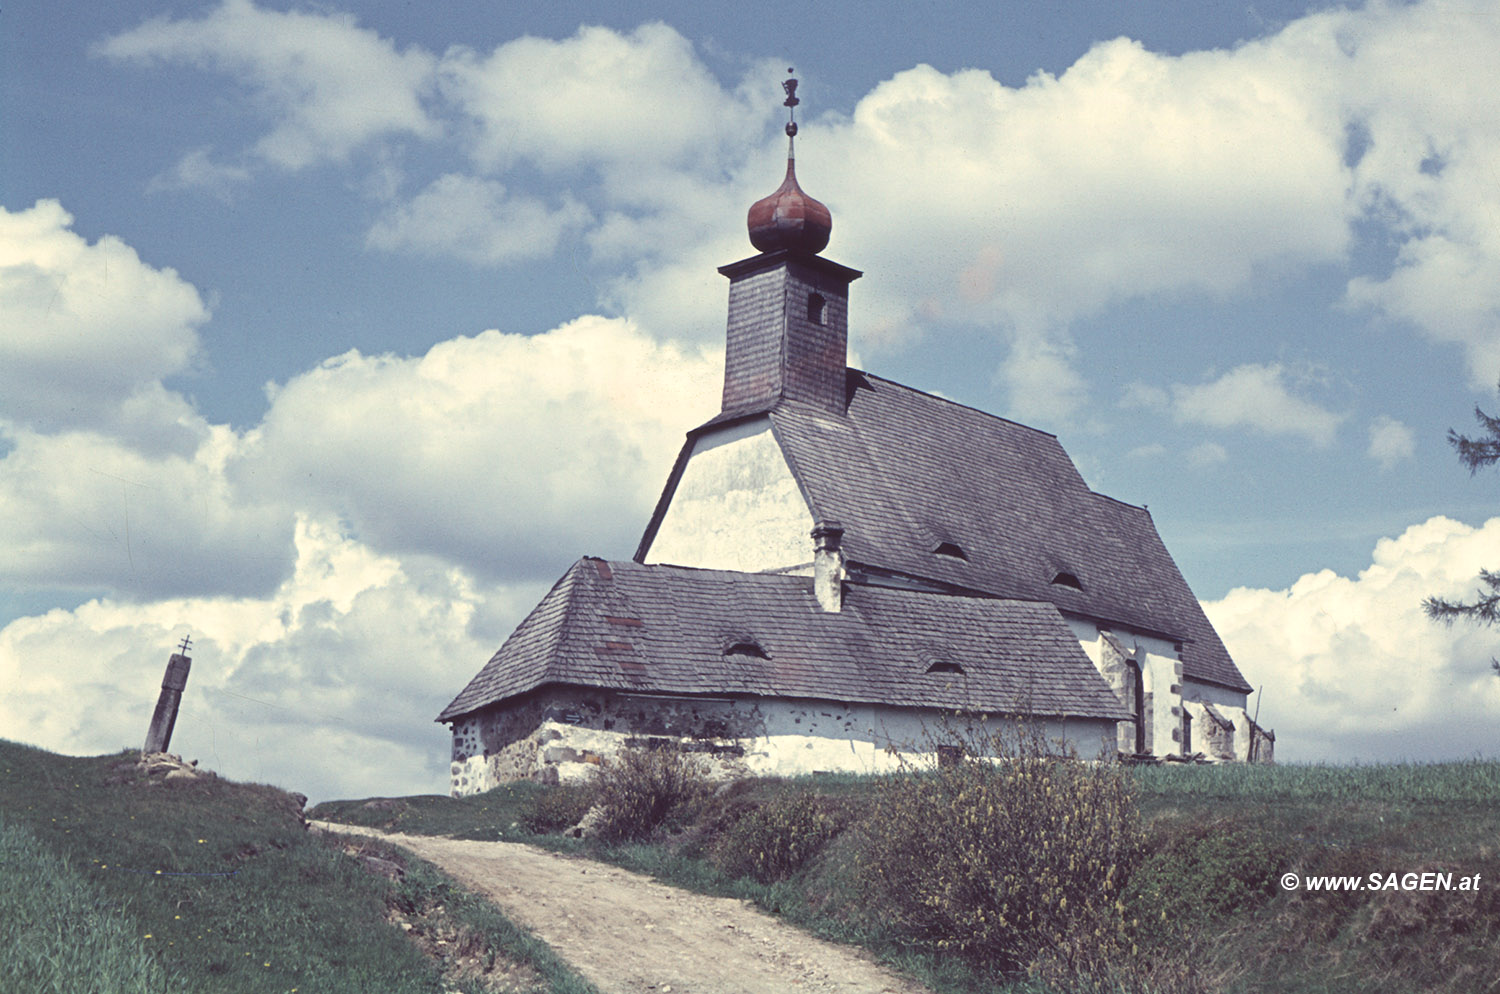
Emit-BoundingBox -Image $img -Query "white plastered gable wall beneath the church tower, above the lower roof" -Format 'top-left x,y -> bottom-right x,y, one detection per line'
645,418 -> 813,573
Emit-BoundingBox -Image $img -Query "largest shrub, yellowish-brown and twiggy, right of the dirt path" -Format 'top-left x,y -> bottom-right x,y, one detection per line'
861,733 -> 1142,975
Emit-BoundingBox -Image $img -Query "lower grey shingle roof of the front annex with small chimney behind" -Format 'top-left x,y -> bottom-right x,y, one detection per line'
438,558 -> 1128,721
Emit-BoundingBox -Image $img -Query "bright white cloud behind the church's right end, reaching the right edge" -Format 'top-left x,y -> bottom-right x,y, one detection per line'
1203,517 -> 1500,762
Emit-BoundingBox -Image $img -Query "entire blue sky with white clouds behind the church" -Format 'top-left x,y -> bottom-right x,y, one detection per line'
0,0 -> 1500,796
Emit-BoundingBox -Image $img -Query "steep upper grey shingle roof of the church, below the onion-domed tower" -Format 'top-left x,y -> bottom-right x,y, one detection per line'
636,369 -> 1251,693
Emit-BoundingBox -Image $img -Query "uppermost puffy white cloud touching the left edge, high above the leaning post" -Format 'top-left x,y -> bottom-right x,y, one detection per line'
0,199 -> 209,429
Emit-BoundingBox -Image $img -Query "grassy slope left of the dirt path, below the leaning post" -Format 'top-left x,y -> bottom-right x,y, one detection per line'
0,741 -> 588,994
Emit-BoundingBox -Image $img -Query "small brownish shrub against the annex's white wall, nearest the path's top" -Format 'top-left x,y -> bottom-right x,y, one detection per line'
594,747 -> 711,841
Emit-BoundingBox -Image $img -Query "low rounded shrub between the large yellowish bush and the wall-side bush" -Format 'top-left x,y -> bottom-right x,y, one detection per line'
713,792 -> 840,883
